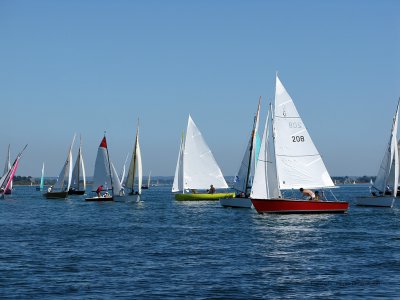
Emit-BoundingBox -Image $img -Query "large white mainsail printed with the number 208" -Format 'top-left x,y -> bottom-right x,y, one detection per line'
274,76 -> 334,189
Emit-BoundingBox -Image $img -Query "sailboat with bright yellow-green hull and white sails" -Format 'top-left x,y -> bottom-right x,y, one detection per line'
172,115 -> 235,200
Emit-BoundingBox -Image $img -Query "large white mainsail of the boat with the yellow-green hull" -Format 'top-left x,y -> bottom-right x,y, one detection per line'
183,115 -> 228,189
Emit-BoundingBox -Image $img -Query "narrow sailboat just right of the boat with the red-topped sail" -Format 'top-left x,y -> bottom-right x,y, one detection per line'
125,122 -> 143,196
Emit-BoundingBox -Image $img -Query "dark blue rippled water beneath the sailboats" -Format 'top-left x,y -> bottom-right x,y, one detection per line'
0,185 -> 400,299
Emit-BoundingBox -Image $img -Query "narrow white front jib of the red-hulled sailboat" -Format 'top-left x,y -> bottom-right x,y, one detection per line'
250,105 -> 281,199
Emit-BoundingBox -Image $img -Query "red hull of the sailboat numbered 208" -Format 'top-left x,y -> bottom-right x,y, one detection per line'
251,199 -> 349,214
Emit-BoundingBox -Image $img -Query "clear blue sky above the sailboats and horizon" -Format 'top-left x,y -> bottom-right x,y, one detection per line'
0,0 -> 400,177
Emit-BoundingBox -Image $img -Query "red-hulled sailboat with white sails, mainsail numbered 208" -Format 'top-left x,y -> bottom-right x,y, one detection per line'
250,76 -> 349,213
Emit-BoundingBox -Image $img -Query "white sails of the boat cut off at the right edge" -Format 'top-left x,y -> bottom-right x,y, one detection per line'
373,103 -> 399,196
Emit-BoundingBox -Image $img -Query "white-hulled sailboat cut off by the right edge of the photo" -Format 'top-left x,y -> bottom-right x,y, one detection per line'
356,99 -> 400,207
